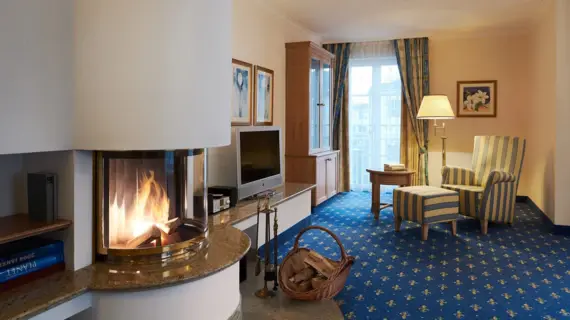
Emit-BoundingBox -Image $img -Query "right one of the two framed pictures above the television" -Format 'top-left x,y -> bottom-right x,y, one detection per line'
254,66 -> 274,126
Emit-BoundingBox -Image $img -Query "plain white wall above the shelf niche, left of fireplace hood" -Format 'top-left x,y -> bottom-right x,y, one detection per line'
0,0 -> 73,154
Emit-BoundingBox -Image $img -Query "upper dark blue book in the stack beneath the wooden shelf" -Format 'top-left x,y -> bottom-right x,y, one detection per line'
0,238 -> 63,271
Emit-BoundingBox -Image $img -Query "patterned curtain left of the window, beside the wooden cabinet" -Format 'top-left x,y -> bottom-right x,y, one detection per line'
324,43 -> 351,191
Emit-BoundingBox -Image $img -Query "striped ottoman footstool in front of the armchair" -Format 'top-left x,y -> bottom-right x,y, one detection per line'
394,186 -> 459,241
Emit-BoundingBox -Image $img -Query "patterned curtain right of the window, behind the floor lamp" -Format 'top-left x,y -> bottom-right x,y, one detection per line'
393,38 -> 429,185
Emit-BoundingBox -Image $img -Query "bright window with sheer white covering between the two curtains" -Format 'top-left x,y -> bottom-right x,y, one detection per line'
349,56 -> 402,191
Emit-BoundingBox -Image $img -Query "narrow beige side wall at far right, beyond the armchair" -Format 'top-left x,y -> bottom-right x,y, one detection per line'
523,1 -> 556,220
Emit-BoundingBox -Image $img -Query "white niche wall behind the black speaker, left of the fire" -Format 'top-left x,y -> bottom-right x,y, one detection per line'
0,151 -> 93,270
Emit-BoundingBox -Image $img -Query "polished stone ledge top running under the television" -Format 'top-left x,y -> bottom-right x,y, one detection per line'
209,182 -> 316,227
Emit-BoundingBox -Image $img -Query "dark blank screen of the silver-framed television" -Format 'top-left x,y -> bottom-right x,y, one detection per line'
240,130 -> 281,184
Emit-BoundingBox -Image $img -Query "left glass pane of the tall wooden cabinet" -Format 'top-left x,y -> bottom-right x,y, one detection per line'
309,58 -> 321,149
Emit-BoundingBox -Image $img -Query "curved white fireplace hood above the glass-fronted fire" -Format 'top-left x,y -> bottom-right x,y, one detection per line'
73,0 -> 232,150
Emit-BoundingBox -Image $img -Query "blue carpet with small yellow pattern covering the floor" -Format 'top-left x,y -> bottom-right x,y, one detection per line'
279,192 -> 570,319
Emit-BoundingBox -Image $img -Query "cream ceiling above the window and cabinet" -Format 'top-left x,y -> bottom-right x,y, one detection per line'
266,0 -> 548,42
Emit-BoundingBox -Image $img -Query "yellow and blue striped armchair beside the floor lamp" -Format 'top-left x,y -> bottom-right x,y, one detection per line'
442,136 -> 526,234
